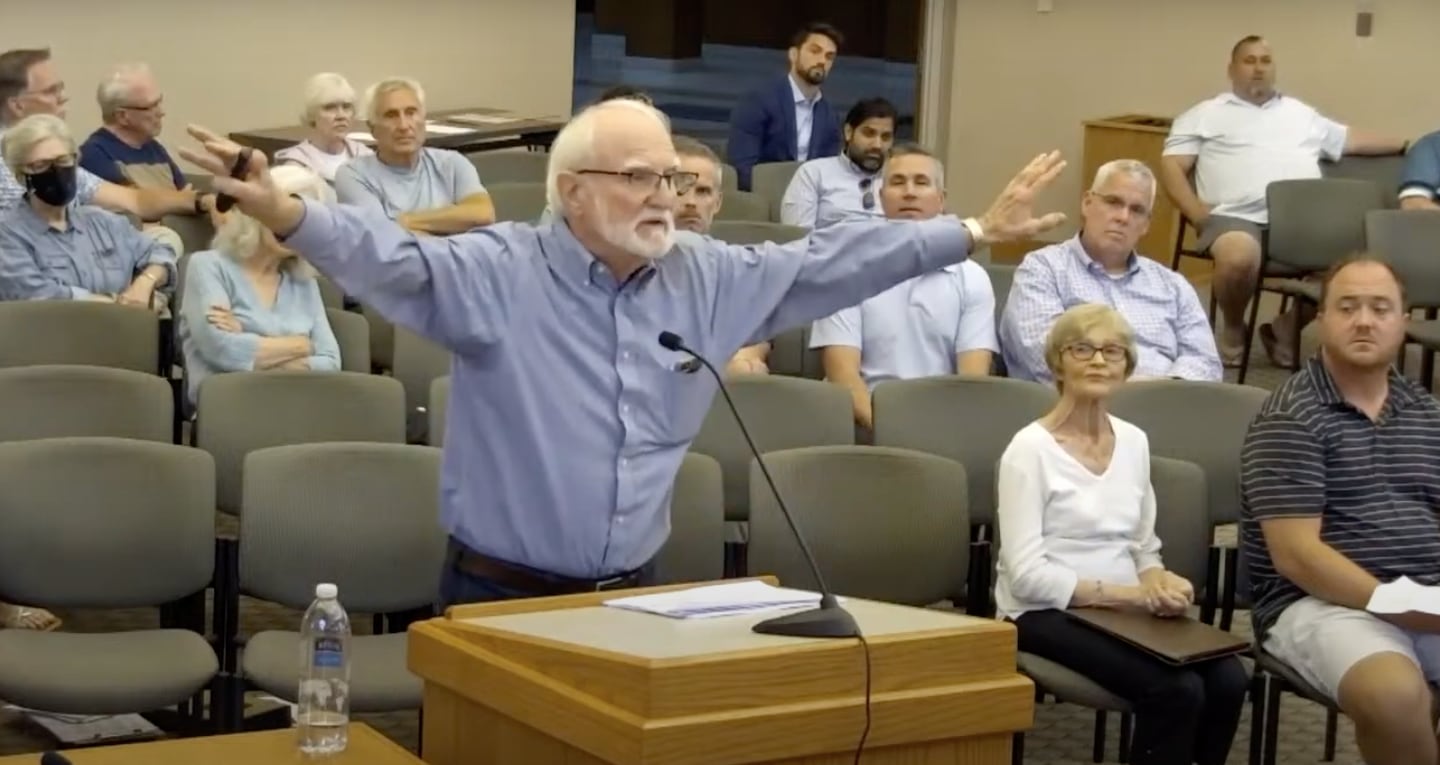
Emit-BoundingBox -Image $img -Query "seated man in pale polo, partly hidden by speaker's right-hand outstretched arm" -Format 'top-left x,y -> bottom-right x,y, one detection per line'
811,146 -> 995,428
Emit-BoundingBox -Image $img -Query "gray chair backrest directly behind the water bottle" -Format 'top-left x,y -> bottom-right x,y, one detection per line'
240,444 -> 446,614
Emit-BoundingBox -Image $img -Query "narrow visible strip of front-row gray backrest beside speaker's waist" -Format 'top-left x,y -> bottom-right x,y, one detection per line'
655,452 -> 724,583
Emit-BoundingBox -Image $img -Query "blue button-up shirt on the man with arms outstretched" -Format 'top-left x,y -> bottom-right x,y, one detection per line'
287,202 -> 971,578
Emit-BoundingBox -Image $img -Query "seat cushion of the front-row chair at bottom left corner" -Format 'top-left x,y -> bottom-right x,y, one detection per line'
0,630 -> 220,715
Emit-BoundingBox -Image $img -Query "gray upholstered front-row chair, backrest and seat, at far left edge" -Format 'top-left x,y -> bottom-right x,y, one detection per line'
0,438 -> 219,715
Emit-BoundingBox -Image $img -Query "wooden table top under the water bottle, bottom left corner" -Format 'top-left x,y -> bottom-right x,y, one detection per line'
0,722 -> 420,765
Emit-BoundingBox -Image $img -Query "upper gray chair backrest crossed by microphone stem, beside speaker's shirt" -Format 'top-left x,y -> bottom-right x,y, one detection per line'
690,375 -> 855,520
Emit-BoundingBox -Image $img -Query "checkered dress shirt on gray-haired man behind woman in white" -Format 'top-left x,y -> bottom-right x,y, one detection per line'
999,235 -> 1224,382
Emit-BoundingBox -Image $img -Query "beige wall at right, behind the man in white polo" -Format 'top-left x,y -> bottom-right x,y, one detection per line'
942,0 -> 1440,238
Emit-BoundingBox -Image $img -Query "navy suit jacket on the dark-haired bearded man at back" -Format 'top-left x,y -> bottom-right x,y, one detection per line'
726,73 -> 840,192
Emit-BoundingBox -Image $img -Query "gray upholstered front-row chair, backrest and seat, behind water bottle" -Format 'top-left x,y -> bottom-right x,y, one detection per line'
232,444 -> 445,725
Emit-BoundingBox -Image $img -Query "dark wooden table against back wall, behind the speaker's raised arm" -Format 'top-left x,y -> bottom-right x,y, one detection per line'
230,107 -> 564,156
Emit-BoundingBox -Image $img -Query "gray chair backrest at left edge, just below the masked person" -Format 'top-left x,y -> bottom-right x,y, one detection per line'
0,300 -> 160,375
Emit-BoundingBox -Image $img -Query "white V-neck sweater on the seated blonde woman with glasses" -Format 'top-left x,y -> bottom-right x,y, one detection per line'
995,416 -> 1161,618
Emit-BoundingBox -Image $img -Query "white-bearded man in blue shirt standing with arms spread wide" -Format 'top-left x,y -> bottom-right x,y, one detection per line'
183,101 -> 1064,604
